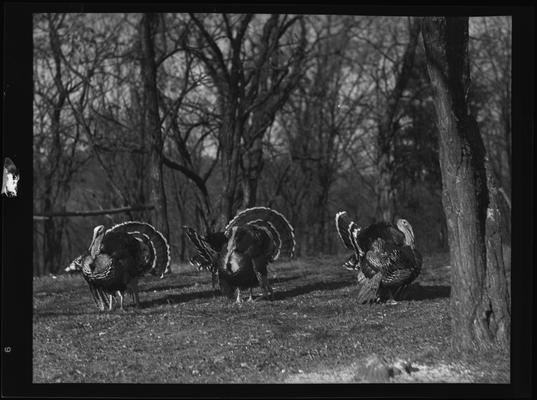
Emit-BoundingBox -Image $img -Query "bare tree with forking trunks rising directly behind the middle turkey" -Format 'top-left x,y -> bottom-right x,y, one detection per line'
187,14 -> 306,224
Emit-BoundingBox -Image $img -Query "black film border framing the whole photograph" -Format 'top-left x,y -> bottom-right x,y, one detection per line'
0,1 -> 535,399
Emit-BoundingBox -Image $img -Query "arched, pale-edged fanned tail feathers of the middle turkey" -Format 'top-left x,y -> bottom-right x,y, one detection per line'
224,207 -> 296,259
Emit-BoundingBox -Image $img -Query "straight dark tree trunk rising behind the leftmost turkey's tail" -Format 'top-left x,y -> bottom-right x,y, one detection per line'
140,14 -> 170,244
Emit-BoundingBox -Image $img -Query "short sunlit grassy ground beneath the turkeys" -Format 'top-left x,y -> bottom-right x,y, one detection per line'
33,255 -> 509,383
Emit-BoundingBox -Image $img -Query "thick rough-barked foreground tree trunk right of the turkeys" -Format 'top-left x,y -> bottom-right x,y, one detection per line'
422,17 -> 510,350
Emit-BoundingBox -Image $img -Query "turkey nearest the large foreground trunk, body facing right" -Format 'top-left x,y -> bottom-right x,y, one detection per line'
336,212 -> 422,304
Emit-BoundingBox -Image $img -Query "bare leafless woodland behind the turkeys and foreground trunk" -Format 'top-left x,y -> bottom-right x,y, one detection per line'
33,13 -> 511,275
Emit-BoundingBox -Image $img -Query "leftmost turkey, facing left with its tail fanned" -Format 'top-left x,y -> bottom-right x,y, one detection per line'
66,221 -> 170,311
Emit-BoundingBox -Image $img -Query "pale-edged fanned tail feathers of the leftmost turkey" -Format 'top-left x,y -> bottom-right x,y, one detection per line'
106,221 -> 171,276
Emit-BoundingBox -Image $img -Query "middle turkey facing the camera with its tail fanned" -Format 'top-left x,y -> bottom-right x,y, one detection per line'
184,207 -> 296,303
